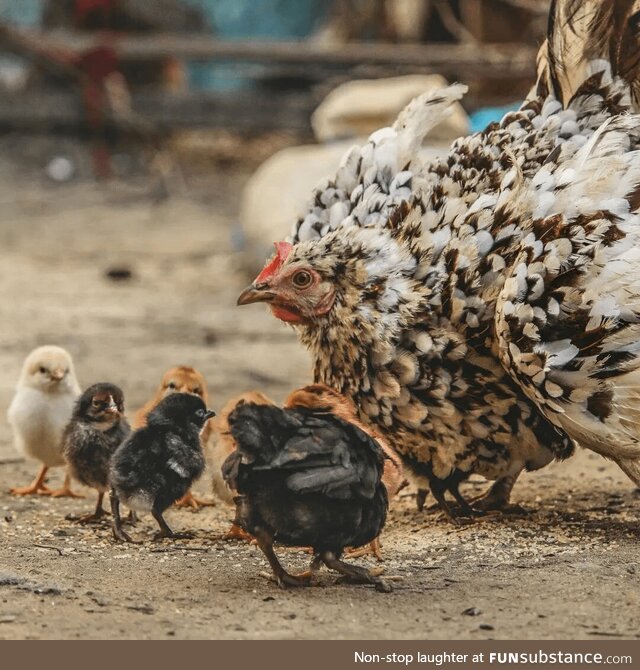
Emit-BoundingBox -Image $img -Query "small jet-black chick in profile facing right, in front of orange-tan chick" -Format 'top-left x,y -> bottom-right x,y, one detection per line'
110,393 -> 215,542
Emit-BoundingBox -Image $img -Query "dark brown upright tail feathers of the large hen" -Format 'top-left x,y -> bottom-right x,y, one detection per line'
536,0 -> 640,108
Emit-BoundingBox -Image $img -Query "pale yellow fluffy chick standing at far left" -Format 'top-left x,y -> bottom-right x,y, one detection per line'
7,345 -> 82,498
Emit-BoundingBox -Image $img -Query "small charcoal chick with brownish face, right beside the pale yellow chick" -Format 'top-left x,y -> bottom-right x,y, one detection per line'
62,383 -> 131,523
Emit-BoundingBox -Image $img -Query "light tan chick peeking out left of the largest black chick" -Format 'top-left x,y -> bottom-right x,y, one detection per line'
204,391 -> 274,540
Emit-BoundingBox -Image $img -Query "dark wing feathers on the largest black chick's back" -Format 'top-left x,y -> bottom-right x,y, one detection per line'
229,404 -> 383,498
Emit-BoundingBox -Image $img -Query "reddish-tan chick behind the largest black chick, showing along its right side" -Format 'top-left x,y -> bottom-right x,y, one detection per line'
284,384 -> 407,561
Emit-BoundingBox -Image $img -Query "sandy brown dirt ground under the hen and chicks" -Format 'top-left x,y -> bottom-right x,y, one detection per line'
0,146 -> 640,639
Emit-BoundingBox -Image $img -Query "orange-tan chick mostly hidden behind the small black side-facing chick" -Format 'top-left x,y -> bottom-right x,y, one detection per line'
132,365 -> 214,510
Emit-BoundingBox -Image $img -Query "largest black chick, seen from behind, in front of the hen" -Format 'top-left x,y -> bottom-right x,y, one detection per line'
222,403 -> 390,591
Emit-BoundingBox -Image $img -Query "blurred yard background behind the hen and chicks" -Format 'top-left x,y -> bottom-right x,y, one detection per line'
0,0 -> 549,453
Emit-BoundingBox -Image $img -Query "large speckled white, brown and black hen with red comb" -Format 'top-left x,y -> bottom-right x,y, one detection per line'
239,0 -> 640,507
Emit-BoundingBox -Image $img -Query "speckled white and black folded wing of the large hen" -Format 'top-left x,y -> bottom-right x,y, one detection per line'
494,116 -> 640,459
